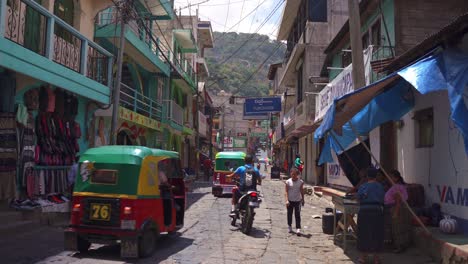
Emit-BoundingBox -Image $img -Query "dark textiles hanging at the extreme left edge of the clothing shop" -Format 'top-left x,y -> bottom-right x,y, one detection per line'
0,113 -> 18,200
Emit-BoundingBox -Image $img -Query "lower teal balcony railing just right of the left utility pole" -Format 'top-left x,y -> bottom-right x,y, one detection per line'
120,83 -> 162,121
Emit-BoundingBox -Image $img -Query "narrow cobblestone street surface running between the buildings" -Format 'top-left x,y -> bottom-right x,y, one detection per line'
0,176 -> 438,264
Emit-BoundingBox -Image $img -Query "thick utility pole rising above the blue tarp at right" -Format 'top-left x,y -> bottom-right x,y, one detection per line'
348,0 -> 366,89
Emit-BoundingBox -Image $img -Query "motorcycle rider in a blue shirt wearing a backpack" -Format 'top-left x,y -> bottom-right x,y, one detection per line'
226,154 -> 262,217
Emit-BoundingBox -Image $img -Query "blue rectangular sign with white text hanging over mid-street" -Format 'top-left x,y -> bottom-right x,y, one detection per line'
244,97 -> 281,117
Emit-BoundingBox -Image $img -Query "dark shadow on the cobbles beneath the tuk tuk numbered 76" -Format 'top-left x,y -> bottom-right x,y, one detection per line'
73,234 -> 194,263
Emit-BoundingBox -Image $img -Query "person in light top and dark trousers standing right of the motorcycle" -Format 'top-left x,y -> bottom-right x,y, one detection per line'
285,168 -> 304,236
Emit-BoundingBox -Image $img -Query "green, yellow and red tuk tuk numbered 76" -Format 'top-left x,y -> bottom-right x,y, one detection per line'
65,146 -> 186,257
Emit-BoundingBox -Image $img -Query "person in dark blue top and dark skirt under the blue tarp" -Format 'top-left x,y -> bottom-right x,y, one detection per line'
356,169 -> 385,263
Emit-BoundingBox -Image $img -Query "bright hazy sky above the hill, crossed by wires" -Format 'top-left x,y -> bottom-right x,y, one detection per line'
175,0 -> 285,38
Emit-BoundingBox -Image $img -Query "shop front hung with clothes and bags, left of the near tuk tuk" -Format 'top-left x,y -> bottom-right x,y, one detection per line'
0,70 -> 97,212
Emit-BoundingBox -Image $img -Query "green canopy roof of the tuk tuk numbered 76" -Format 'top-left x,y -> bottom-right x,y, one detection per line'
80,146 -> 179,165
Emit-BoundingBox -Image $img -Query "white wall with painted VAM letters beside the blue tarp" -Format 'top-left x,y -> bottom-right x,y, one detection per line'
398,92 -> 468,219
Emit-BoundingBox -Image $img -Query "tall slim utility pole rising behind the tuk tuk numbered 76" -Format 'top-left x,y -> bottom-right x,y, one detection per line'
110,0 -> 133,145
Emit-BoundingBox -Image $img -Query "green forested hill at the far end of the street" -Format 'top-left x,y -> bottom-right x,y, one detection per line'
205,32 -> 285,96
